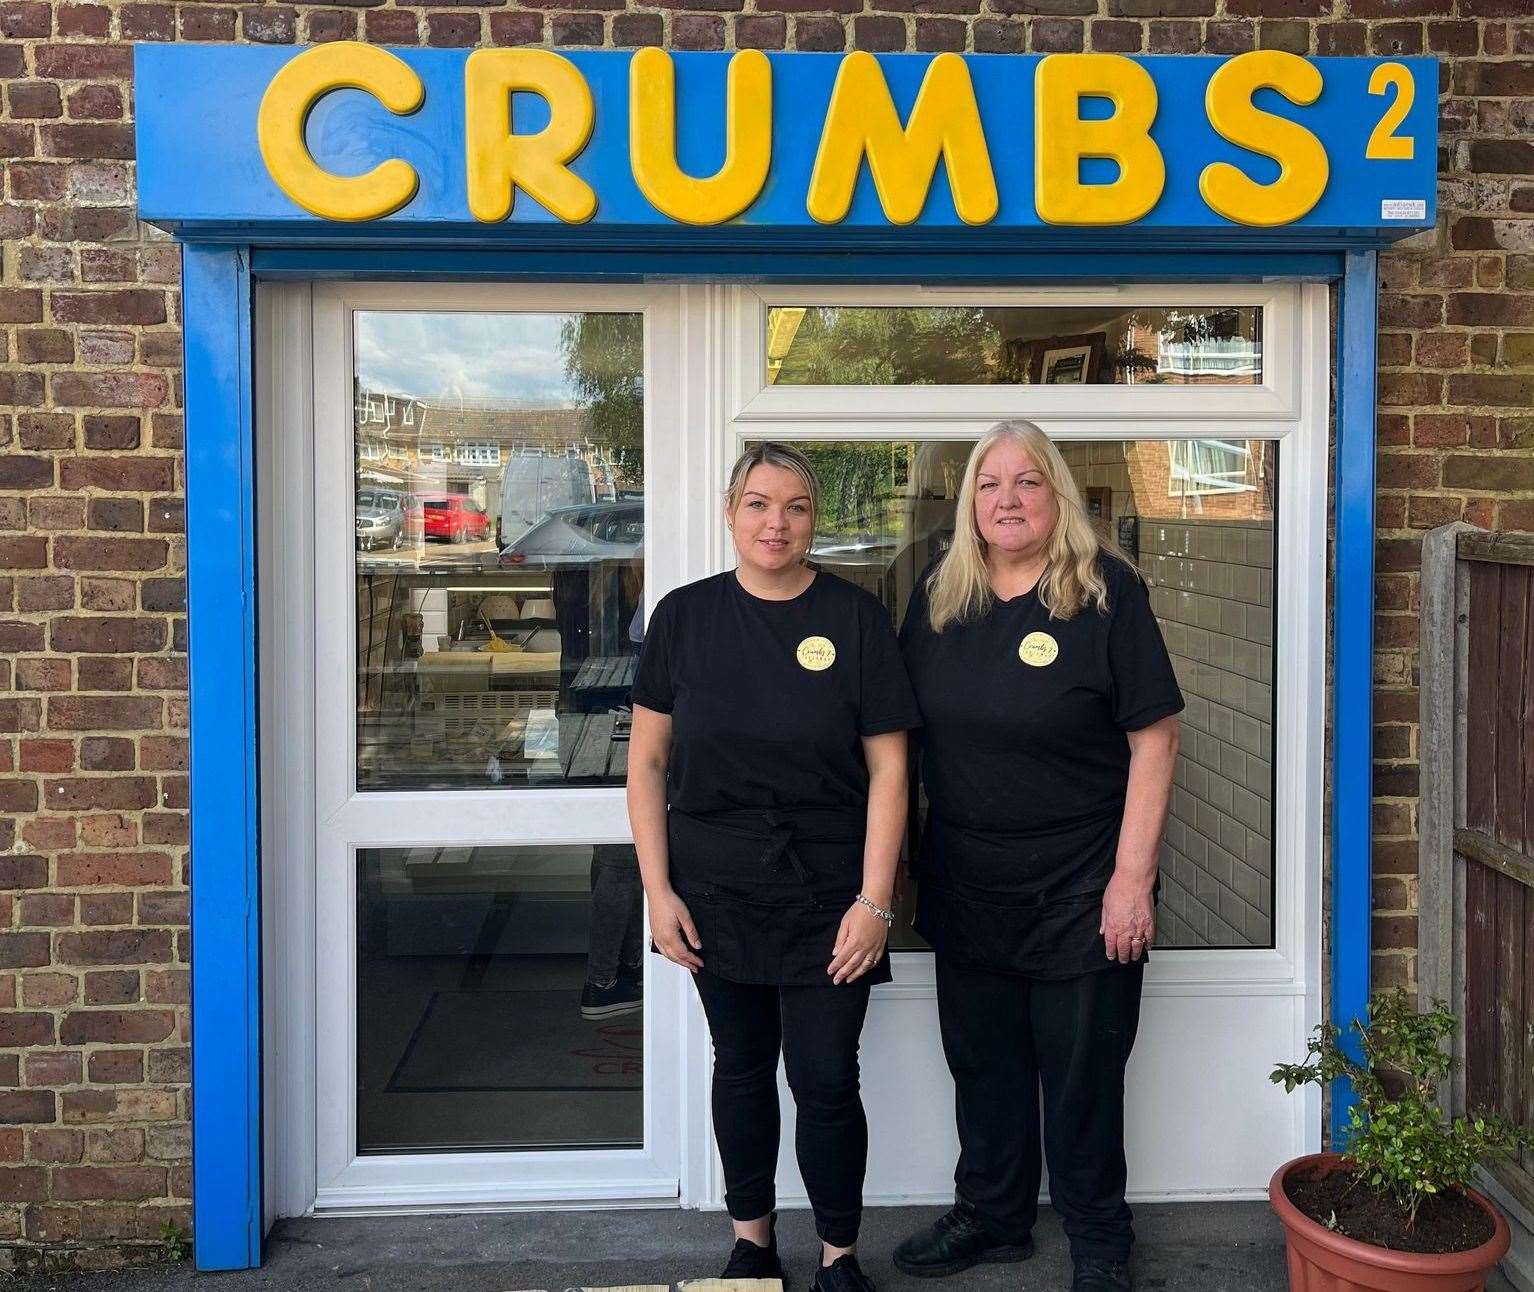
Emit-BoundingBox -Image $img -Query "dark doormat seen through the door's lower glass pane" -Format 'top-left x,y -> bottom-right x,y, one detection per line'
385,991 -> 644,1094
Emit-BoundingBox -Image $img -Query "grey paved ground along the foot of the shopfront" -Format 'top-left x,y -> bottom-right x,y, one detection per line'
0,1203 -> 1287,1292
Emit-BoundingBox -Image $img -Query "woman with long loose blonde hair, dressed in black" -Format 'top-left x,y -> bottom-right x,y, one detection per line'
894,422 -> 1183,1292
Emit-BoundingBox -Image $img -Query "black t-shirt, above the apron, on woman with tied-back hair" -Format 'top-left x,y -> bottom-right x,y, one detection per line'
632,571 -> 920,813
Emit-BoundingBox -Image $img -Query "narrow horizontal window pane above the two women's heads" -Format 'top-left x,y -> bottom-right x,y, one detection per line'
767,304 -> 1262,385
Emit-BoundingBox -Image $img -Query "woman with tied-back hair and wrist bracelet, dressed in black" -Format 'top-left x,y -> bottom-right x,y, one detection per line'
629,443 -> 920,1292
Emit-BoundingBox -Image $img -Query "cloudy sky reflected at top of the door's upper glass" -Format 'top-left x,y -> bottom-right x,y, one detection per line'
356,310 -> 575,405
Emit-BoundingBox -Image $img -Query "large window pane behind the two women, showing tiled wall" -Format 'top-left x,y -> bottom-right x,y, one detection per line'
773,439 -> 1278,947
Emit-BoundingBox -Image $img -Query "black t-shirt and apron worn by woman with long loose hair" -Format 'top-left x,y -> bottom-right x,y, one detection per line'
900,557 -> 1183,977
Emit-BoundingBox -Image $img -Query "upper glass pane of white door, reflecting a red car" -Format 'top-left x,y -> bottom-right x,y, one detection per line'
353,310 -> 644,790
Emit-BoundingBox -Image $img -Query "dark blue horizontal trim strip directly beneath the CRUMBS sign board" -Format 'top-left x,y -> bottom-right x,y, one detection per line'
252,242 -> 1342,285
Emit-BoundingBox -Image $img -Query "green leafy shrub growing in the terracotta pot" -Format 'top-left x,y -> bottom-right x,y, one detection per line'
1272,988 -> 1534,1224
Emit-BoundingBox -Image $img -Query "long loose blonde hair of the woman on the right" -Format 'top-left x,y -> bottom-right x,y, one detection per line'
927,420 -> 1138,632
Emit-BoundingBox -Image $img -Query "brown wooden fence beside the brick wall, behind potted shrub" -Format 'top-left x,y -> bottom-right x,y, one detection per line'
1417,525 -> 1534,1286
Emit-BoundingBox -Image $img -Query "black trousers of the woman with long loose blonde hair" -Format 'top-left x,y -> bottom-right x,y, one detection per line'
937,956 -> 1144,1261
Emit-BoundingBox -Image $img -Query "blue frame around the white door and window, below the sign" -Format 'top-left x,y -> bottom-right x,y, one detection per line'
183,235 -> 1376,1271
